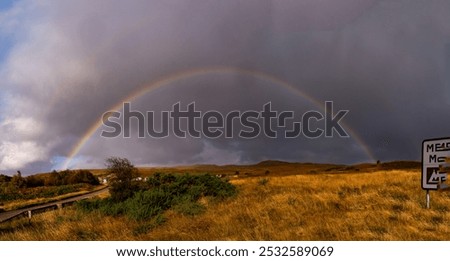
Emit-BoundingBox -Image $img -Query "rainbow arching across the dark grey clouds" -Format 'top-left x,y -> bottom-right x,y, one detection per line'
62,67 -> 375,169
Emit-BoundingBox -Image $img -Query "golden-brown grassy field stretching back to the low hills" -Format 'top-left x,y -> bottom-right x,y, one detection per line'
0,162 -> 450,240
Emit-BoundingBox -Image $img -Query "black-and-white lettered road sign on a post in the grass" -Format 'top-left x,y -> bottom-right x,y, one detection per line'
422,138 -> 450,190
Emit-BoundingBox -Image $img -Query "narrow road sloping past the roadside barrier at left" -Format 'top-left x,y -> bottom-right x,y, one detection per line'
0,187 -> 109,223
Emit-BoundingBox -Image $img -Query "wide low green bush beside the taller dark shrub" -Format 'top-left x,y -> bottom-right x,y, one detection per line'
77,173 -> 236,220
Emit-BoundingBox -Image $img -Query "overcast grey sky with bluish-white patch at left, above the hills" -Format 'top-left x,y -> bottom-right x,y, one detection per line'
0,0 -> 450,174
